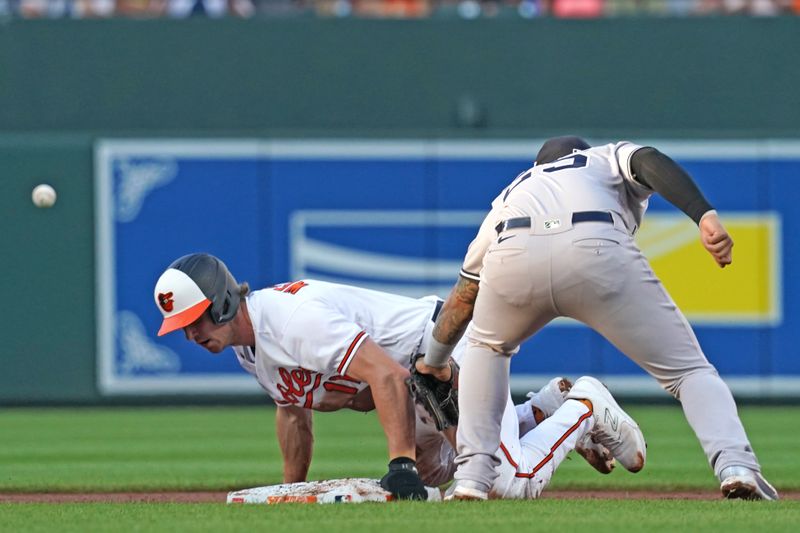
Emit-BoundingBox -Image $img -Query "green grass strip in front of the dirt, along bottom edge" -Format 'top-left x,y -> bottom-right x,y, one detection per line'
0,500 -> 800,533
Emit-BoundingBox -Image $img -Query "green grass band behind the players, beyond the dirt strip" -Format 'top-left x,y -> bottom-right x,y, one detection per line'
0,406 -> 800,492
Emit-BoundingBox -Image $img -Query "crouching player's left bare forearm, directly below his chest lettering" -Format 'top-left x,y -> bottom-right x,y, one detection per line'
275,405 -> 314,483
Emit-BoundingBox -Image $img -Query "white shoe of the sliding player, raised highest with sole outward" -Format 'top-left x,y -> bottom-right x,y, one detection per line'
567,376 -> 647,472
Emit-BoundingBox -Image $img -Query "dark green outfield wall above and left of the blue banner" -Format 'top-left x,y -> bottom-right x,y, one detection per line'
0,17 -> 800,405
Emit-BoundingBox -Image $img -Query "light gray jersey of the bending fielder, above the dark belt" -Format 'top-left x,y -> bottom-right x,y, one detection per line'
461,141 -> 653,281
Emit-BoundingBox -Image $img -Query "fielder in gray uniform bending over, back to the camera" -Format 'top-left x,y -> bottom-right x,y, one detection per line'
417,137 -> 778,500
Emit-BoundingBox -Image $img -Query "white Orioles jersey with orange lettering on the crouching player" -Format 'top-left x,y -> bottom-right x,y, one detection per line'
233,280 -> 437,410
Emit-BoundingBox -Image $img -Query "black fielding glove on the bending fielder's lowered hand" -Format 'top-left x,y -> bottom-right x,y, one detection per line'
406,354 -> 458,431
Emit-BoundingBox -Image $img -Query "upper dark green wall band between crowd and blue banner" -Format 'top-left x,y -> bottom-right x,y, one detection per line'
0,17 -> 800,136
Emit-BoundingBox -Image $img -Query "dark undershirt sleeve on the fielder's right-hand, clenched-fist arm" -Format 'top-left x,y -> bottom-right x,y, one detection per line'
631,146 -> 714,224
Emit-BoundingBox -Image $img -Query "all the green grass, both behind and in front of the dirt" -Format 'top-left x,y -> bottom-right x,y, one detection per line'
0,406 -> 800,531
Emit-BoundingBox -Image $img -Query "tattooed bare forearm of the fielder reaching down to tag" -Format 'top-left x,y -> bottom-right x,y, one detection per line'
416,276 -> 478,381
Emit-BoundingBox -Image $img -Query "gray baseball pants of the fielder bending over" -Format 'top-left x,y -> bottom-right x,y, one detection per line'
455,215 -> 760,490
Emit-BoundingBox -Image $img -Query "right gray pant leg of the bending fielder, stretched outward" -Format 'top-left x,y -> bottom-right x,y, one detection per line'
554,224 -> 760,494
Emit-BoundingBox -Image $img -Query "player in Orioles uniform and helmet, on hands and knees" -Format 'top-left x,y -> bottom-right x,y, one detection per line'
155,254 -> 645,499
